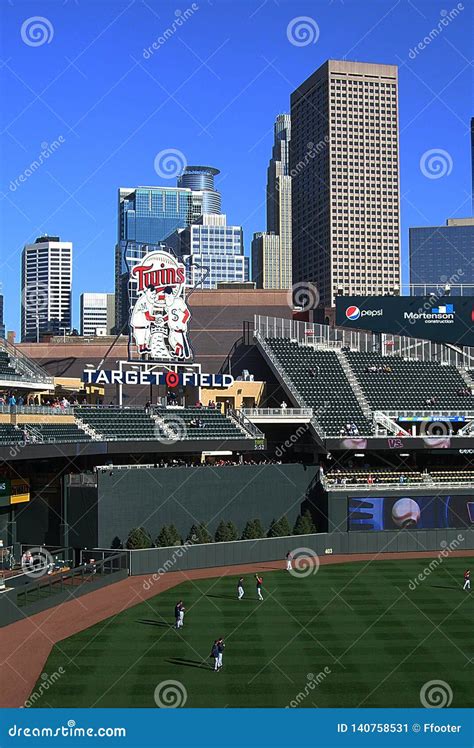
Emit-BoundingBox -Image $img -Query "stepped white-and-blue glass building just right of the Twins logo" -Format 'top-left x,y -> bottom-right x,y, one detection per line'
173,213 -> 249,289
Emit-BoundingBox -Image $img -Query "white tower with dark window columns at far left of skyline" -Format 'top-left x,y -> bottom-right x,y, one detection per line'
21,236 -> 72,341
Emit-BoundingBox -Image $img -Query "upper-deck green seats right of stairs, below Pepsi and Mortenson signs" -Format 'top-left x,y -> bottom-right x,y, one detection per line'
345,352 -> 474,410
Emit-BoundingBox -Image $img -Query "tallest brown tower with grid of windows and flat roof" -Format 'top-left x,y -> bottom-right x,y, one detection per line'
290,60 -> 400,305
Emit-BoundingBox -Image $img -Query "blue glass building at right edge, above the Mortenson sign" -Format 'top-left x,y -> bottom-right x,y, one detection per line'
409,218 -> 474,296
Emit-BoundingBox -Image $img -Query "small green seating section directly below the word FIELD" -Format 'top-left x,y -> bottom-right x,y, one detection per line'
157,407 -> 249,440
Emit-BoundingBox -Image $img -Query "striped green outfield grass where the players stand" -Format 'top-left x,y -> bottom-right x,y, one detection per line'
31,558 -> 474,708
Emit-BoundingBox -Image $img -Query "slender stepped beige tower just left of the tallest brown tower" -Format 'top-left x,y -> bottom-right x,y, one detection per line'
252,114 -> 292,289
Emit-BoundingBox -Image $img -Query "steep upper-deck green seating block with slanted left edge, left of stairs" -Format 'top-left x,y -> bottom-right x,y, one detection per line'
265,338 -> 373,436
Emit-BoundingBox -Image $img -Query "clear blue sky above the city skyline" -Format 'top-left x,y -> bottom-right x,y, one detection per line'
0,0 -> 474,331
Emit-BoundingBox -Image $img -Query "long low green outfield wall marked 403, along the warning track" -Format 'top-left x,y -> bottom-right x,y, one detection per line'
123,529 -> 474,581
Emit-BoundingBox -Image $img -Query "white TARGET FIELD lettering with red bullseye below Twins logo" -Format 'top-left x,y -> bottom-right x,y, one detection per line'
82,369 -> 234,389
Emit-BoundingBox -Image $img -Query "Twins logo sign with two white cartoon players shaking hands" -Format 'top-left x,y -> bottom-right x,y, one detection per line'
130,250 -> 192,362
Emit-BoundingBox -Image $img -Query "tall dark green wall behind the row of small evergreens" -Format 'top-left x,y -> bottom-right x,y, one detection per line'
66,464 -> 319,548
